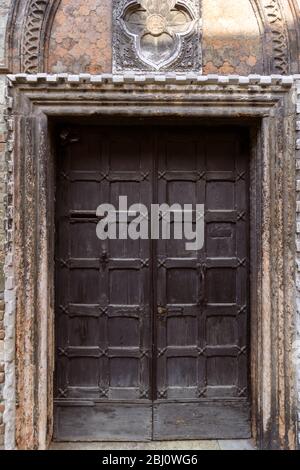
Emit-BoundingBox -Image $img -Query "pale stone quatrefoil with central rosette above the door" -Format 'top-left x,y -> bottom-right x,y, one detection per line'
121,0 -> 197,70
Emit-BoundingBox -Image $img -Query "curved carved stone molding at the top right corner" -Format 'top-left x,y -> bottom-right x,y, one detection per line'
261,0 -> 290,74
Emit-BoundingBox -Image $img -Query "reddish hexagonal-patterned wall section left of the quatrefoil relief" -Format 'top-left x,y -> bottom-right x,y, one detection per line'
48,0 -> 112,73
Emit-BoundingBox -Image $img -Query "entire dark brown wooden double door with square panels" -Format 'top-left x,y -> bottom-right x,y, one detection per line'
55,126 -> 250,440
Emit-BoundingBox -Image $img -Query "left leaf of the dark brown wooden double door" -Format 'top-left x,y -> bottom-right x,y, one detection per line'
55,128 -> 152,440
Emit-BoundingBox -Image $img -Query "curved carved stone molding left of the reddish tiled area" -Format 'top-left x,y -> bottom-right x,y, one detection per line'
21,0 -> 50,73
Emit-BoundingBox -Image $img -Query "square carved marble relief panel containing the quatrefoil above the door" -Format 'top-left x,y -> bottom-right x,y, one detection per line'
113,0 -> 201,72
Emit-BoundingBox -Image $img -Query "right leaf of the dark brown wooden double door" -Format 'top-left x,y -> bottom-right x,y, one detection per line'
154,128 -> 249,439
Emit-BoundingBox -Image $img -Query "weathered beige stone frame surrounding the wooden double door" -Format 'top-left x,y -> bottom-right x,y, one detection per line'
4,74 -> 296,449
